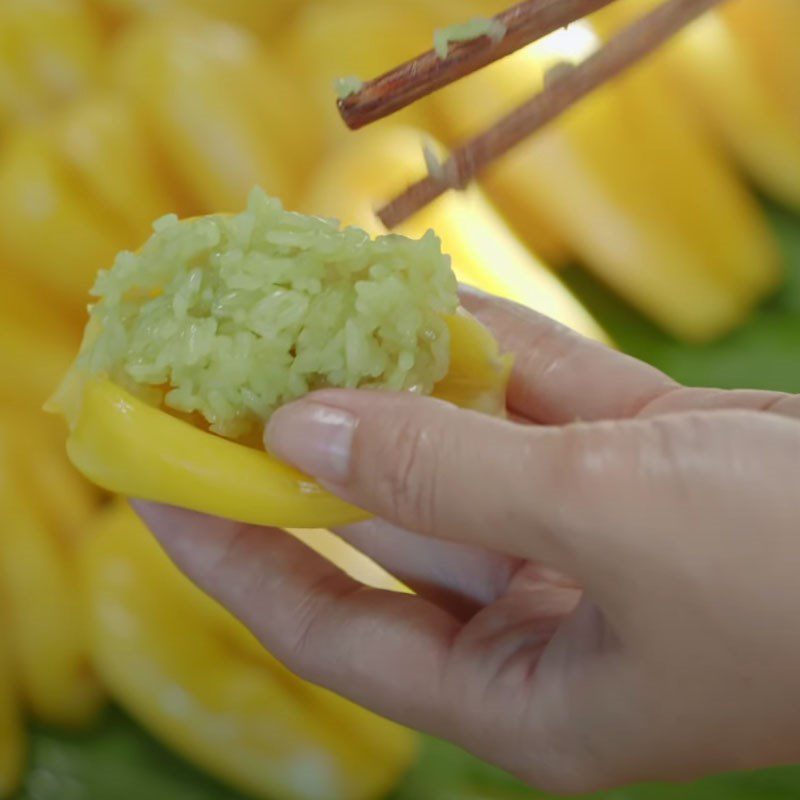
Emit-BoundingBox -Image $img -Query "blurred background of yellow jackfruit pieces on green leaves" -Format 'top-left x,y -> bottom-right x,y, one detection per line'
0,0 -> 800,800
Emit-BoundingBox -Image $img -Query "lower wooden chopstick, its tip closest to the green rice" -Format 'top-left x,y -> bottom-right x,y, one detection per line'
378,0 -> 723,229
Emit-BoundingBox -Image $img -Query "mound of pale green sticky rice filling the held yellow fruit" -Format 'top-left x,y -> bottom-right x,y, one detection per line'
79,189 -> 458,438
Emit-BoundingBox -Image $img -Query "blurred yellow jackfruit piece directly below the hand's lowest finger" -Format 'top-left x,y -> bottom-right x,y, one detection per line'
83,506 -> 416,800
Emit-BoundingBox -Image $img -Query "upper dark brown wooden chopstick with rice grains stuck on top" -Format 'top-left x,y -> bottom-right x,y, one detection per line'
339,0 -> 614,130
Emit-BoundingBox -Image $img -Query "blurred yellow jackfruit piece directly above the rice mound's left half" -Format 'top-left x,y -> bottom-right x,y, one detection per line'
113,15 -> 313,213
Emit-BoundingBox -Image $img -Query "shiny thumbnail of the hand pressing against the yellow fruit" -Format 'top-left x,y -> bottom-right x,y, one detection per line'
264,401 -> 358,483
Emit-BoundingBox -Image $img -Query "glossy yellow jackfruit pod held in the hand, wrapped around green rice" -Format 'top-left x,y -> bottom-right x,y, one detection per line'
49,317 -> 510,528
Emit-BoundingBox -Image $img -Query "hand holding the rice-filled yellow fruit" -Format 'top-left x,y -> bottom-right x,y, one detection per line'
138,291 -> 800,794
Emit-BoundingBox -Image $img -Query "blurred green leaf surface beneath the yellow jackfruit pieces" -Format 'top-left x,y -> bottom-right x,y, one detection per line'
19,203 -> 800,800
